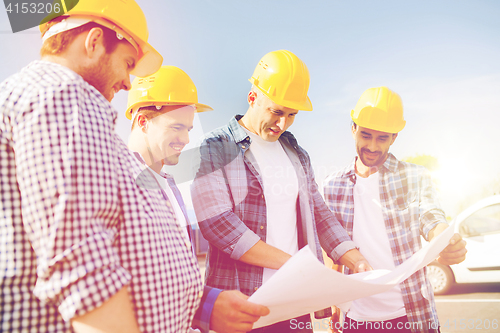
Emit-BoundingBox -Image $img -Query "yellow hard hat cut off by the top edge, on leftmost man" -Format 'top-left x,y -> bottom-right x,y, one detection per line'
39,0 -> 163,76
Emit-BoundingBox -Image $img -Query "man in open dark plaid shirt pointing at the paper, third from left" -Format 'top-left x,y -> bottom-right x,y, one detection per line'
192,50 -> 369,332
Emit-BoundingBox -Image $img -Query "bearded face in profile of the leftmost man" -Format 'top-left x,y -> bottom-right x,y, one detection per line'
80,34 -> 137,102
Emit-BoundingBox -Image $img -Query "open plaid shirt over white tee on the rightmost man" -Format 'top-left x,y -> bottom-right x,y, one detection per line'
324,153 -> 446,332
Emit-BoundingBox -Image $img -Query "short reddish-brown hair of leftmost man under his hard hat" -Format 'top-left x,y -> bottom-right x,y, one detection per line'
40,16 -> 127,57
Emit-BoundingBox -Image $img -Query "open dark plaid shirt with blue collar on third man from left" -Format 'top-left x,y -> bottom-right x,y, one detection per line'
191,116 -> 355,306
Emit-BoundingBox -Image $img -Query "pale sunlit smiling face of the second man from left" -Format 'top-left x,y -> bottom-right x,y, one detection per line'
143,105 -> 195,166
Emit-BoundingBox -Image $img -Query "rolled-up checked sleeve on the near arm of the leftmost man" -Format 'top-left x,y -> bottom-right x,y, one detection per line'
12,80 -> 131,321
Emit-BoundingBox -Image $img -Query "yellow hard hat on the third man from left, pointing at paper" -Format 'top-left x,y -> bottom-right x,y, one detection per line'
249,50 -> 312,111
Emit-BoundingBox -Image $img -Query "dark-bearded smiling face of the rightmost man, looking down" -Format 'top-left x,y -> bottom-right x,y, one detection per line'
352,124 -> 398,173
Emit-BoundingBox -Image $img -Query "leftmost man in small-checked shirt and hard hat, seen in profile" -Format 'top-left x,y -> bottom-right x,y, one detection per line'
0,0 -> 266,333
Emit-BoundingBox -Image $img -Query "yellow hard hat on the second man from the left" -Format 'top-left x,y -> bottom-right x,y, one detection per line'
125,66 -> 213,120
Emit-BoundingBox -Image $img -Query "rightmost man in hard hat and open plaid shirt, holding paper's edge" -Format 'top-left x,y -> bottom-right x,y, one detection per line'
324,87 -> 466,333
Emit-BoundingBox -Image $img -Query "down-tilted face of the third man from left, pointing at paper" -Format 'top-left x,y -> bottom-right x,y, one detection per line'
240,89 -> 299,142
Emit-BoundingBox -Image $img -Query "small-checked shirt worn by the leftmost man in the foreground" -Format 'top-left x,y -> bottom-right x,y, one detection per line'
0,61 -> 203,333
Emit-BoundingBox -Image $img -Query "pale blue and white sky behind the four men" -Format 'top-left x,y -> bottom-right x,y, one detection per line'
0,0 -> 500,216
